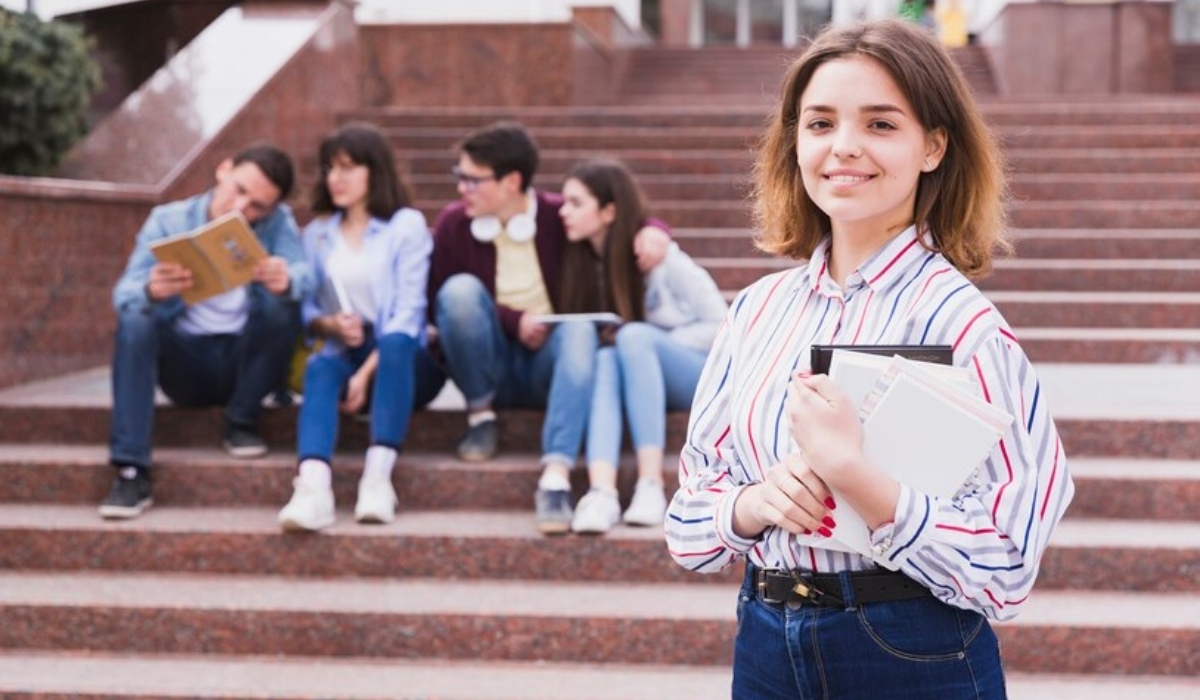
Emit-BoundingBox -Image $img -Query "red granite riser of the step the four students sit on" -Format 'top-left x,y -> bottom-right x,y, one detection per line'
0,407 -> 1200,460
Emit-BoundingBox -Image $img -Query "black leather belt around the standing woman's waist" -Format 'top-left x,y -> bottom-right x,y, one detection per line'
752,568 -> 931,608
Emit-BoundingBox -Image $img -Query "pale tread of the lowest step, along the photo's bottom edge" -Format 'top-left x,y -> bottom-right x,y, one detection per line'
0,651 -> 1200,700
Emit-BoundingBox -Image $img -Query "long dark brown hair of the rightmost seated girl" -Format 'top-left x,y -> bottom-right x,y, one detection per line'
562,160 -> 646,321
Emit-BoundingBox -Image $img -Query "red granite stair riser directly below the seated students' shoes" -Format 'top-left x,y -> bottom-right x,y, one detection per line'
0,530 -> 1200,594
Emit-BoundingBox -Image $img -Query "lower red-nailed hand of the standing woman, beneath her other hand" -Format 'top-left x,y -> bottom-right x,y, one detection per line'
733,453 -> 836,538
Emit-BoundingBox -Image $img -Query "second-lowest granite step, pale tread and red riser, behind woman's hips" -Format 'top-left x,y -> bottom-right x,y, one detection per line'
0,572 -> 1200,678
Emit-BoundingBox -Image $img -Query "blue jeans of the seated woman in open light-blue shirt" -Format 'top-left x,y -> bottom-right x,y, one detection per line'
296,333 -> 416,463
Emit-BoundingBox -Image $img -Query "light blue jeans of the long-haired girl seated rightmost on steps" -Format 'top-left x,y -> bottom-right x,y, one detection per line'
587,323 -> 708,465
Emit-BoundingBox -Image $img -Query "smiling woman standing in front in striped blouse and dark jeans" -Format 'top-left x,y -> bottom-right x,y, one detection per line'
666,20 -> 1073,700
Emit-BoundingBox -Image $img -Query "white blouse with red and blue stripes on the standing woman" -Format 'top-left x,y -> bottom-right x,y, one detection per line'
666,227 -> 1074,620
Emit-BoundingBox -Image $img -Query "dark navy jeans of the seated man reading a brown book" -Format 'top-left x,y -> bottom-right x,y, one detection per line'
108,285 -> 300,468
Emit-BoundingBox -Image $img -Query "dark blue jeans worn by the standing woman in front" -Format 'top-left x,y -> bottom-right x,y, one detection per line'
732,566 -> 1006,700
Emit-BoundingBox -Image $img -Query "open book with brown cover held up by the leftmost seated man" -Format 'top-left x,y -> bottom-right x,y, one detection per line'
150,211 -> 266,304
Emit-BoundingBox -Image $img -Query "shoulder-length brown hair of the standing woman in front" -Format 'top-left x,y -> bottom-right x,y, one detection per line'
754,19 -> 1010,277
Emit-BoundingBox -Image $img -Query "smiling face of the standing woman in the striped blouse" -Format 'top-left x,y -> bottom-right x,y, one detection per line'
796,56 -> 946,235
